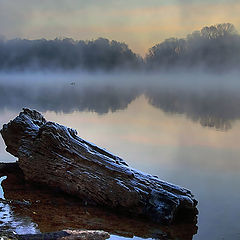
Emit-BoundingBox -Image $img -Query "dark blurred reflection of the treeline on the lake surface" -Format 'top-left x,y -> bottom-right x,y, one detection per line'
0,79 -> 240,131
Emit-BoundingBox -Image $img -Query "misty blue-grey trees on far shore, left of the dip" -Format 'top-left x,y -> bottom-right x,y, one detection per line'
0,38 -> 141,70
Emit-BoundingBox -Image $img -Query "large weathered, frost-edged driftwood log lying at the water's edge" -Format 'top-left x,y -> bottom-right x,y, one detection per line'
1,109 -> 197,223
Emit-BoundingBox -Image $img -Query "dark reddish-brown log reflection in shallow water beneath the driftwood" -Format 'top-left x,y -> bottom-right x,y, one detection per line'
0,163 -> 197,240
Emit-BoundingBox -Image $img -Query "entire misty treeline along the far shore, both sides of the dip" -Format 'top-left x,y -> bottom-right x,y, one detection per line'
0,23 -> 240,71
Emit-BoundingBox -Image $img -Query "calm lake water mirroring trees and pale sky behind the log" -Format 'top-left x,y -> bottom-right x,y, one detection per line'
0,74 -> 240,240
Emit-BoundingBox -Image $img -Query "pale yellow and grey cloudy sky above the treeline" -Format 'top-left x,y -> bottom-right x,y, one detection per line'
0,0 -> 240,55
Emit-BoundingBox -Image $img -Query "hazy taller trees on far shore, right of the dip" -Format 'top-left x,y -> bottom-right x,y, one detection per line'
145,23 -> 240,70
